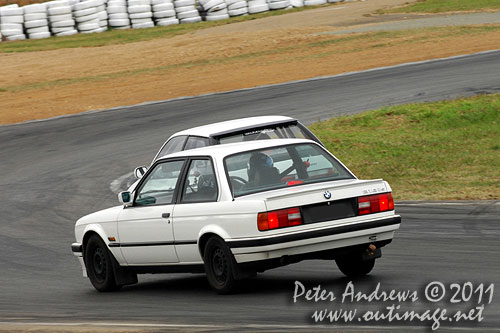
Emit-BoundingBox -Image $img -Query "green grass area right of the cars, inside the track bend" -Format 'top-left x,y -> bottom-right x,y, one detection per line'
310,94 -> 500,200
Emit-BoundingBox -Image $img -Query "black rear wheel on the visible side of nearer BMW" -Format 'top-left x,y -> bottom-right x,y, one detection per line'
203,237 -> 236,294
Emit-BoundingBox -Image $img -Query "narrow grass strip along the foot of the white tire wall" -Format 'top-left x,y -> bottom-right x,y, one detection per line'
0,4 -> 320,53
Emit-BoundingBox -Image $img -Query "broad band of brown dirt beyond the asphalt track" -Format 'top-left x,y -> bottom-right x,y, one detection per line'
0,0 -> 500,124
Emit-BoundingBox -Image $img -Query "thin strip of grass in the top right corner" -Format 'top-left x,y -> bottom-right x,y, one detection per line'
383,0 -> 500,13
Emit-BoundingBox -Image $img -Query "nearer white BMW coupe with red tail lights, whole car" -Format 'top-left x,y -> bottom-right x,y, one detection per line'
72,139 -> 401,294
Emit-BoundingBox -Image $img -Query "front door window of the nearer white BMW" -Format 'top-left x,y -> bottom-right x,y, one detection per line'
134,160 -> 184,206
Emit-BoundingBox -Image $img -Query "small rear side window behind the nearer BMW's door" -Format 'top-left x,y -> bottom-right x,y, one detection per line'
181,159 -> 217,203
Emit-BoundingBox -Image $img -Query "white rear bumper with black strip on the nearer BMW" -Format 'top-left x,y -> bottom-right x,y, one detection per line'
227,215 -> 401,263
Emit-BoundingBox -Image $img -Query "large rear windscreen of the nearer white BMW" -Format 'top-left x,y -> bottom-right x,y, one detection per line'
224,143 -> 354,197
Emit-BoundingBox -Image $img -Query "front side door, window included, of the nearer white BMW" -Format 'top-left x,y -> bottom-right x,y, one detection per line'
118,159 -> 185,265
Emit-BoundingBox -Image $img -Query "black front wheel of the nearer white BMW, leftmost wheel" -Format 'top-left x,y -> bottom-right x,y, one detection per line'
83,235 -> 121,291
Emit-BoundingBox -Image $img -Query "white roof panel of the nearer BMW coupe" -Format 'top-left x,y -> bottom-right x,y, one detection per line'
159,139 -> 319,160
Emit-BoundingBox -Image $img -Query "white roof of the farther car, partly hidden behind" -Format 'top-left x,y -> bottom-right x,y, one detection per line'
172,116 -> 296,138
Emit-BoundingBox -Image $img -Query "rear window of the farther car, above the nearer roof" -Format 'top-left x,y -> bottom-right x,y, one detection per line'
217,124 -> 315,144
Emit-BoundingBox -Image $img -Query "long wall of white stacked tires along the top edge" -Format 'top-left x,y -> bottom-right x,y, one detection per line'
0,0 -> 345,42
